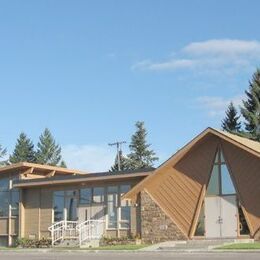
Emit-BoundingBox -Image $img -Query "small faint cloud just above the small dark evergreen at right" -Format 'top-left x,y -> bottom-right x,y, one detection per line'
197,95 -> 244,117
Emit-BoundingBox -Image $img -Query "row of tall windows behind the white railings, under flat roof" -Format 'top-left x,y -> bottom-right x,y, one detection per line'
53,185 -> 131,228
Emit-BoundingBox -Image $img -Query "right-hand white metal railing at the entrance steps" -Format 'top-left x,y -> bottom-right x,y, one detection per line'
76,220 -> 105,246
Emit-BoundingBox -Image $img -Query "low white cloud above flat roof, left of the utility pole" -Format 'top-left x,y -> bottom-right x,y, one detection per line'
62,145 -> 115,172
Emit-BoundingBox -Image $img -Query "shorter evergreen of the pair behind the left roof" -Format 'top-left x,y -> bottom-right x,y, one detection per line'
9,133 -> 35,163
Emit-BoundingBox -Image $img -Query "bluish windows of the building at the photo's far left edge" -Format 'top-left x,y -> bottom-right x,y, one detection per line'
0,178 -> 20,217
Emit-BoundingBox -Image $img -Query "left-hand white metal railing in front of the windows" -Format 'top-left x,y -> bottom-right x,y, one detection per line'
48,220 -> 78,245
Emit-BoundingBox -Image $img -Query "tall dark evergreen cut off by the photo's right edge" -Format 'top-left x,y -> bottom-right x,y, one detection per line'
241,69 -> 260,141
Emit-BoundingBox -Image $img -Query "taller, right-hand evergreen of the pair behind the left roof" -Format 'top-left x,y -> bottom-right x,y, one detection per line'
36,128 -> 65,166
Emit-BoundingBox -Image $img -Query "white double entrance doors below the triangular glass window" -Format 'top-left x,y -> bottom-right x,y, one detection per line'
205,195 -> 238,238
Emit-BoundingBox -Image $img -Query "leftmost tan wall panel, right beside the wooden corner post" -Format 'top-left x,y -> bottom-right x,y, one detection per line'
23,189 -> 40,238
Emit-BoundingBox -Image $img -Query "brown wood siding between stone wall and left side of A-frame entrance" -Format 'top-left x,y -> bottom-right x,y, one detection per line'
146,135 -> 219,237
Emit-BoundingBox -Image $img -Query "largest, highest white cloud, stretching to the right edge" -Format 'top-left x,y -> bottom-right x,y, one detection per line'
132,39 -> 260,72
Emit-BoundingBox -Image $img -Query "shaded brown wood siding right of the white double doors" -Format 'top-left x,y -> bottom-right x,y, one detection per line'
222,141 -> 260,236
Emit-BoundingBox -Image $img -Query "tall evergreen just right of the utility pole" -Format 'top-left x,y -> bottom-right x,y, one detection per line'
128,121 -> 158,170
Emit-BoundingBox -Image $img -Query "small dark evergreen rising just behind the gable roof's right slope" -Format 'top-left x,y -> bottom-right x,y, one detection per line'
222,102 -> 241,134
